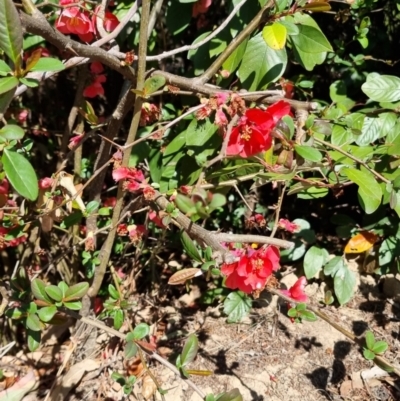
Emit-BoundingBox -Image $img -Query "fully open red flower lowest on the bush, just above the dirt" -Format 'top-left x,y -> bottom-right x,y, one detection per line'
221,246 -> 279,294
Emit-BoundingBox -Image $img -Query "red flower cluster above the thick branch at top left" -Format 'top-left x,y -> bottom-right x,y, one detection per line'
56,0 -> 119,42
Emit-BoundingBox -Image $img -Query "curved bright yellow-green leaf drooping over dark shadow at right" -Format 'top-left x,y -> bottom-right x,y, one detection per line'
340,168 -> 382,214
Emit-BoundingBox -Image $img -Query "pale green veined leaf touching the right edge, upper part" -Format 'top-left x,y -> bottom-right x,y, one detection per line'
361,72 -> 400,102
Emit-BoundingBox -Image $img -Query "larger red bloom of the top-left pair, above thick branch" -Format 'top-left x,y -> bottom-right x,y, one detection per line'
56,7 -> 94,42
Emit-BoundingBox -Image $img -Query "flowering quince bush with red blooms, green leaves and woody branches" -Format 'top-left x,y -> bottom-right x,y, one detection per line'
0,0 -> 400,401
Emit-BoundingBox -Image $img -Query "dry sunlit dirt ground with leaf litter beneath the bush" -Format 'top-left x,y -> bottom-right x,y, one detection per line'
0,270 -> 400,401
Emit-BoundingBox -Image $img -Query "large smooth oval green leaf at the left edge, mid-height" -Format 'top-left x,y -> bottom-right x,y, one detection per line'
1,148 -> 39,201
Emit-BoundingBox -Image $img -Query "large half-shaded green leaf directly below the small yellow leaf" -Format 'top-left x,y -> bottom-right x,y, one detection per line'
237,33 -> 287,91
